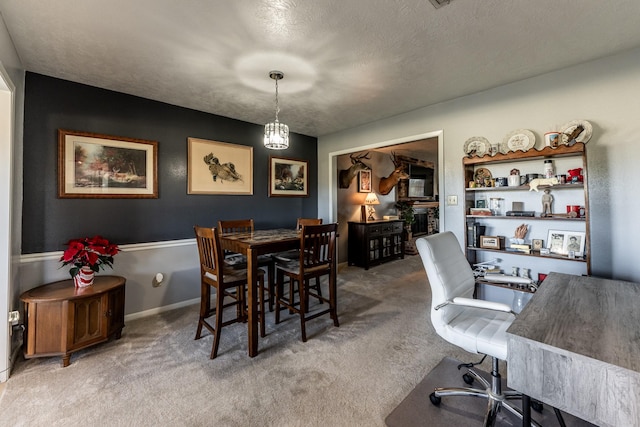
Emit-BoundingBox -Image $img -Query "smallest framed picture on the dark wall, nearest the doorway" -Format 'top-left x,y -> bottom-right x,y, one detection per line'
269,156 -> 309,197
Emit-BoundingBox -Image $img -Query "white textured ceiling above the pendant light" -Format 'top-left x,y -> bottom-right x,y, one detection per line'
0,0 -> 640,136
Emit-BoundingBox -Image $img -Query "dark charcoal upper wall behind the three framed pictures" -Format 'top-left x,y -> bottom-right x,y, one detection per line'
22,73 -> 318,254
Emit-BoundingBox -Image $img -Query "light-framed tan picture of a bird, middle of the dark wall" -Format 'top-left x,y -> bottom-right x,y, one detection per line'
187,138 -> 253,195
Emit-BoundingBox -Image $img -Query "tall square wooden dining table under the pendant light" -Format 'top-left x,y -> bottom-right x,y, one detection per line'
220,228 -> 301,357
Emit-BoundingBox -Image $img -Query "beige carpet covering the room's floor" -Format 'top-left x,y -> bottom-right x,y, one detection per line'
0,257 -> 504,426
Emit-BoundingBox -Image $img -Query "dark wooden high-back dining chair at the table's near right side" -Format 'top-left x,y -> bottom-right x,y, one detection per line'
275,223 -> 340,342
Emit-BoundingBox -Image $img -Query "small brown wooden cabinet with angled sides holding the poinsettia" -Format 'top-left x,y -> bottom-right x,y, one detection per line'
20,276 -> 126,366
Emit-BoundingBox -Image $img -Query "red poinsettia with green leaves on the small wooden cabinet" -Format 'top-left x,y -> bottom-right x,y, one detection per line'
60,236 -> 120,277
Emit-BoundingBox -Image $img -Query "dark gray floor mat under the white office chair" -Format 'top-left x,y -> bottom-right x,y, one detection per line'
386,357 -> 593,427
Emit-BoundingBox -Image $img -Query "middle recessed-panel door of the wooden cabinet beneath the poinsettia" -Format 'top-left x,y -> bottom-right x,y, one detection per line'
67,295 -> 108,351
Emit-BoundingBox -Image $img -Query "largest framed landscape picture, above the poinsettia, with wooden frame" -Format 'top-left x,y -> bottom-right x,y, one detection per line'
58,129 -> 158,199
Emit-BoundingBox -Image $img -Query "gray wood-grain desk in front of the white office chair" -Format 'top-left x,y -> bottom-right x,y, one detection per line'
507,273 -> 640,426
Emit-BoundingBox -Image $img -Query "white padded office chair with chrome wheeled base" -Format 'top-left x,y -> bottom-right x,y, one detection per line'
416,231 -> 539,426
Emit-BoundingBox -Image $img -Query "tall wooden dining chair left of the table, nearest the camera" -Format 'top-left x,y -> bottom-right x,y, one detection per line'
194,226 -> 265,359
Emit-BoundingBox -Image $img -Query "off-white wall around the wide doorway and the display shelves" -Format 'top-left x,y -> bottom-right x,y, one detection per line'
318,49 -> 640,282
